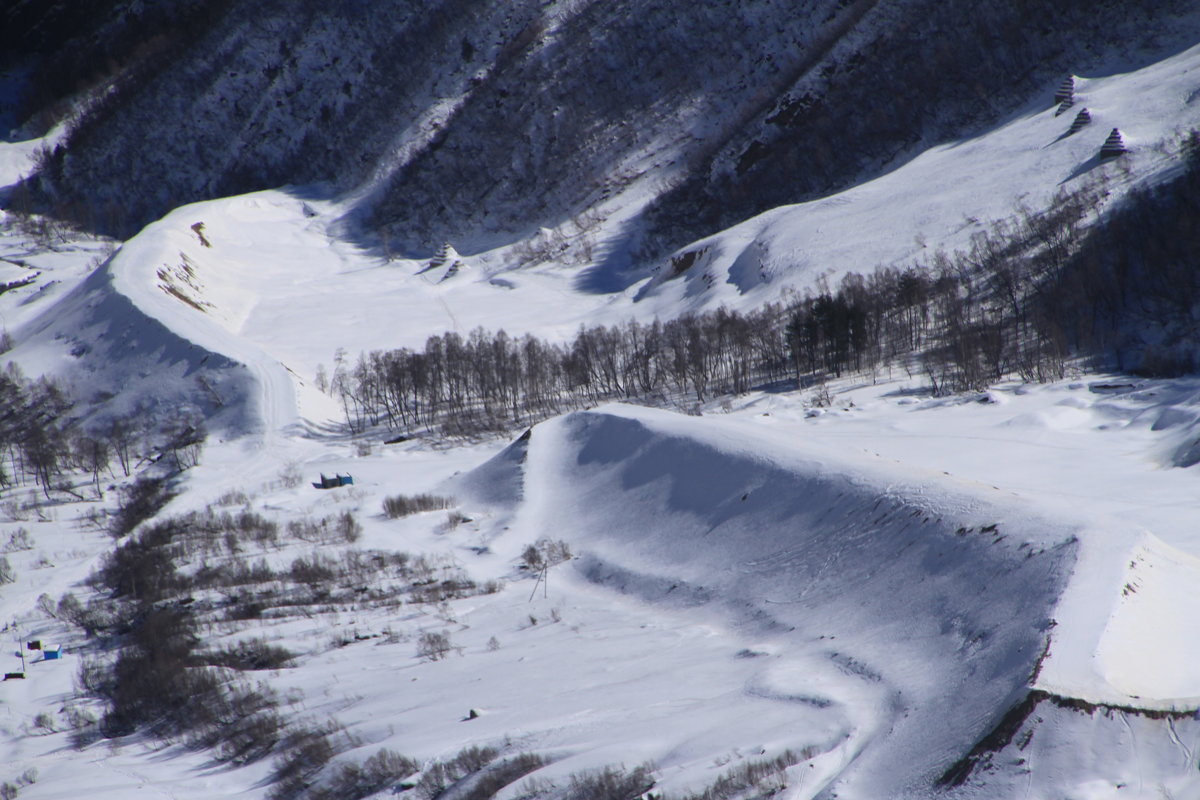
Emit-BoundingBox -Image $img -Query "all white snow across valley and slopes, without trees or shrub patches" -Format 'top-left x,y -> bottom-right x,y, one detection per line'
0,28 -> 1200,800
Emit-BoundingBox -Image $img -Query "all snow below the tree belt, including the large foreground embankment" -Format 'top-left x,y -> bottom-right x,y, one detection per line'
7,371 -> 1200,798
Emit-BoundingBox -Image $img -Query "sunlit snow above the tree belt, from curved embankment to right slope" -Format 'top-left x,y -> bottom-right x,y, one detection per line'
9,32 -> 1200,438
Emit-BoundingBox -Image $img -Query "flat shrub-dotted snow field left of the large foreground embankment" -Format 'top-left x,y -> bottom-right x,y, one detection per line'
2,429 -> 847,798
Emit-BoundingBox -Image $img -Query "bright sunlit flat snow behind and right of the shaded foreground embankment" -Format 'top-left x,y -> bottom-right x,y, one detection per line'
748,379 -> 1200,710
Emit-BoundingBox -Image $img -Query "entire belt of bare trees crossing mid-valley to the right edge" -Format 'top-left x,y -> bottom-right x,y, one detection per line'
331,133 -> 1200,434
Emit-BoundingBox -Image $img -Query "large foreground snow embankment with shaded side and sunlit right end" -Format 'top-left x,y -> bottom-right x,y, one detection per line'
454,407 -> 1200,798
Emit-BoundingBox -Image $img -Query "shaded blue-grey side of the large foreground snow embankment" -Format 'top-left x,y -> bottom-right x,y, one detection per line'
482,407 -> 1076,796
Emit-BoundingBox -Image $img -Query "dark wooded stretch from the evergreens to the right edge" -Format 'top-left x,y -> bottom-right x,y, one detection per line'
748,132 -> 1200,392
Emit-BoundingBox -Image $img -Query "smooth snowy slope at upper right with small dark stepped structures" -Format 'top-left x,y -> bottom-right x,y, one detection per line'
638,38 -> 1200,308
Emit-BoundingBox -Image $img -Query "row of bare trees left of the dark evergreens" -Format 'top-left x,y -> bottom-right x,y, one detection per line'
331,305 -> 788,433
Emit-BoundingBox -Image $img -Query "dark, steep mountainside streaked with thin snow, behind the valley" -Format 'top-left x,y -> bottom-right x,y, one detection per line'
11,0 -> 1194,266
